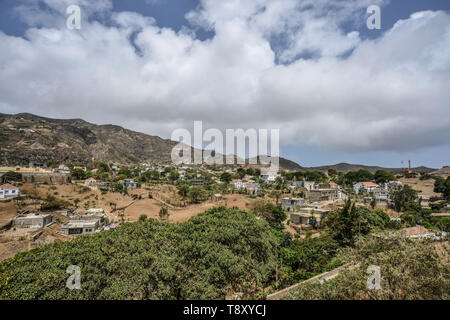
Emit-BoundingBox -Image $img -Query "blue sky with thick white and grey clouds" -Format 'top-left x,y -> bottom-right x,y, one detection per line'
0,0 -> 450,168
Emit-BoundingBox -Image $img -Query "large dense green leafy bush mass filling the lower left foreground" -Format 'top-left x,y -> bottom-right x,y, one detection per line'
0,207 -> 278,299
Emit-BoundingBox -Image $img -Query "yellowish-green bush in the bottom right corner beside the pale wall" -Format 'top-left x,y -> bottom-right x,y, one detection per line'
286,237 -> 450,300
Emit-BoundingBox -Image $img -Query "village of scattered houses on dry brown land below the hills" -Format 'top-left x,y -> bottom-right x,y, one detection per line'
0,163 -> 450,260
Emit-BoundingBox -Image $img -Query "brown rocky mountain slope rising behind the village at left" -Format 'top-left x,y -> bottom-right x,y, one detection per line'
0,113 -> 176,165
